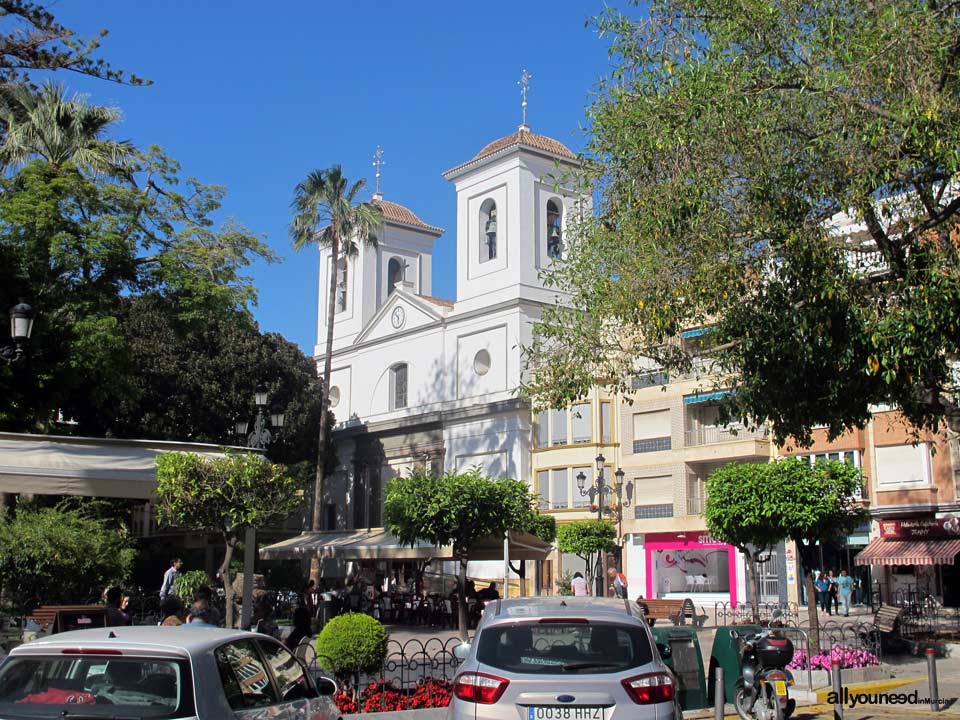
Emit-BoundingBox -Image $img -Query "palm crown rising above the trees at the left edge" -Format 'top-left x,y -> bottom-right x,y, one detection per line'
0,82 -> 136,175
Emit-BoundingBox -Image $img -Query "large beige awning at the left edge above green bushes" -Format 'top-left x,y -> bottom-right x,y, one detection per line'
0,433 -> 246,500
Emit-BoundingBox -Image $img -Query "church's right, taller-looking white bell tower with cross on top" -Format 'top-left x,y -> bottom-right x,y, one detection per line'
443,69 -> 576,309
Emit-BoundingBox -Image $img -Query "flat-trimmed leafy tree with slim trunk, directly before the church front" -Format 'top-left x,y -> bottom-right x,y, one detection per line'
383,468 -> 533,639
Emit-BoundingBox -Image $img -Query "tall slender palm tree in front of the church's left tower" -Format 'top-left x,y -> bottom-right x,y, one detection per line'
290,165 -> 383,564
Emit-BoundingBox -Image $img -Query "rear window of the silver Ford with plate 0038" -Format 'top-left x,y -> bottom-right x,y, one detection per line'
477,622 -> 653,674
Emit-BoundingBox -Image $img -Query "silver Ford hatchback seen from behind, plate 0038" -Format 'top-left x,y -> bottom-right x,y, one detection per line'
447,597 -> 683,720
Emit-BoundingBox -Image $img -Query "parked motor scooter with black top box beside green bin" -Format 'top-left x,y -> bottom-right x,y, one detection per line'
734,628 -> 797,720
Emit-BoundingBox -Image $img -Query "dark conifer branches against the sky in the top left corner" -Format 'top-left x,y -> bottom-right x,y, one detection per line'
0,0 -> 149,85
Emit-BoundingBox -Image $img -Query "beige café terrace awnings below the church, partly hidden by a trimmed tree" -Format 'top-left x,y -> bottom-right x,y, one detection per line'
260,528 -> 552,560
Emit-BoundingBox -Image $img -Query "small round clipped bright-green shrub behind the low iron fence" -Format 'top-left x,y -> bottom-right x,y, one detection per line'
317,613 -> 389,678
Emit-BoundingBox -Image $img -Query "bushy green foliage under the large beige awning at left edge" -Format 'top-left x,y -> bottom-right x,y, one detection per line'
0,505 -> 136,606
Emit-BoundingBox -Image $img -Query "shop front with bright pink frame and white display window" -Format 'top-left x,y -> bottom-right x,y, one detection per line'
642,531 -> 744,606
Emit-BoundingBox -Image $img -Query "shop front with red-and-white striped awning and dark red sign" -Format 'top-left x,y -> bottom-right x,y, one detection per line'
856,515 -> 960,607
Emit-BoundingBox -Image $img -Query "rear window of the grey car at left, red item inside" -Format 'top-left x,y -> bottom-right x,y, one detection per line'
0,655 -> 196,720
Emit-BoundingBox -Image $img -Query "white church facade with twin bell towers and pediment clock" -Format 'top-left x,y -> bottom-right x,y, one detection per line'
316,125 -> 583,530
